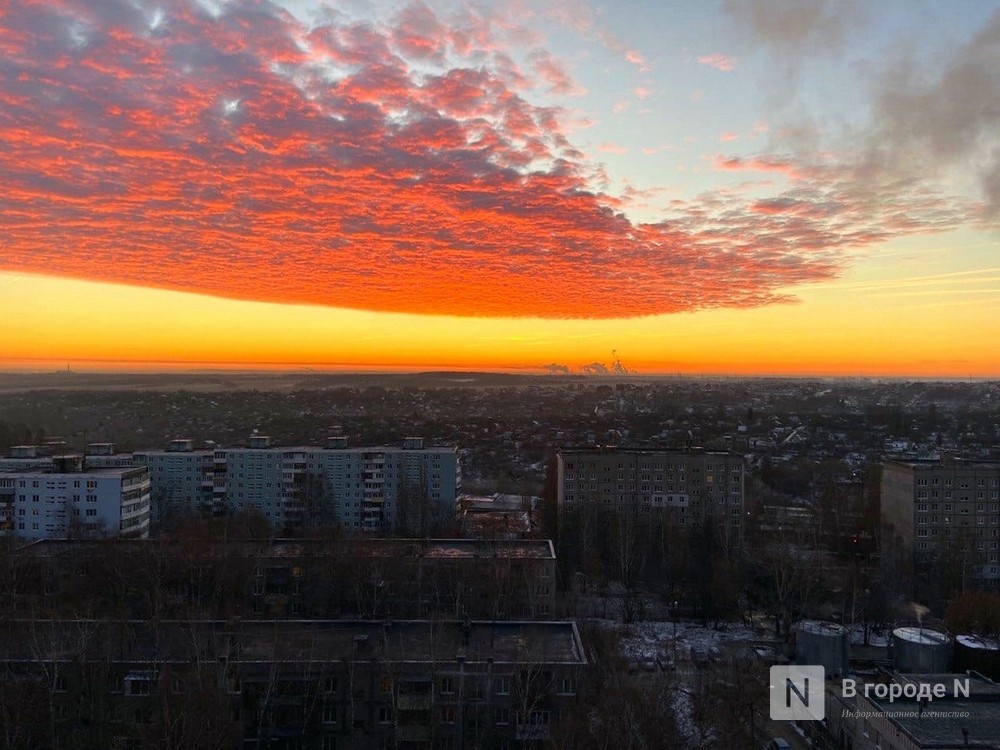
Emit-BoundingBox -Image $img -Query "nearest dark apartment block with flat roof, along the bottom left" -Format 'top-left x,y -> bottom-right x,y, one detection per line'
0,620 -> 587,750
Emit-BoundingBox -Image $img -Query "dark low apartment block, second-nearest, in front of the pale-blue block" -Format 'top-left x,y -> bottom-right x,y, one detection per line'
15,536 -> 556,620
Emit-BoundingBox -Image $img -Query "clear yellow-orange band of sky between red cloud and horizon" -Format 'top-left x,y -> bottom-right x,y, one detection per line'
0,229 -> 1000,377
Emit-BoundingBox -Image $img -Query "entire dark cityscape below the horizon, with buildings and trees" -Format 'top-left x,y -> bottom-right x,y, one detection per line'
0,372 -> 1000,750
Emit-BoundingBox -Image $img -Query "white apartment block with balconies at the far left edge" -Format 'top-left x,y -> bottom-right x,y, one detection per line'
0,455 -> 150,539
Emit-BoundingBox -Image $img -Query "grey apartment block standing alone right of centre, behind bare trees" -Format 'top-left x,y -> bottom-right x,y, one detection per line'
556,446 -> 744,535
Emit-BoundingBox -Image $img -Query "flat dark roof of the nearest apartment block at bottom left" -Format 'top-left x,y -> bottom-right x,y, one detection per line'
0,620 -> 587,666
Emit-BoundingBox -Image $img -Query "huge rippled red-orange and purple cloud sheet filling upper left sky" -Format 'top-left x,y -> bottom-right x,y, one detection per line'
0,0 -> 972,317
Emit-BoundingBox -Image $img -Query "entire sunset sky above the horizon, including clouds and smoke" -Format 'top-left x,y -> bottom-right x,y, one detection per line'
0,0 -> 1000,378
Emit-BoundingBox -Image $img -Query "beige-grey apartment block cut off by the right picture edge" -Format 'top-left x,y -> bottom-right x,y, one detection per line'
881,455 -> 1000,585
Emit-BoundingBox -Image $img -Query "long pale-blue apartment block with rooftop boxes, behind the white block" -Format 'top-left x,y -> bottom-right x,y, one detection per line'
0,435 -> 460,535
